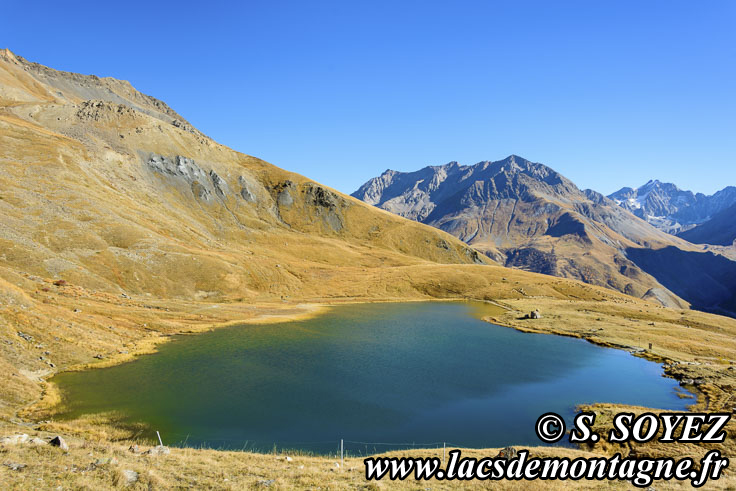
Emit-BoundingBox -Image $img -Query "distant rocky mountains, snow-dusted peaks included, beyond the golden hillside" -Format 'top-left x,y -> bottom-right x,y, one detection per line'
352,155 -> 736,311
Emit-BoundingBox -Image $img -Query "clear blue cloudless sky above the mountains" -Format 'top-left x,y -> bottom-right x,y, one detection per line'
0,0 -> 736,194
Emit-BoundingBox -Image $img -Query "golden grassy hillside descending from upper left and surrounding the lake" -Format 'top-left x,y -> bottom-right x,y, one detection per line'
0,51 -> 736,489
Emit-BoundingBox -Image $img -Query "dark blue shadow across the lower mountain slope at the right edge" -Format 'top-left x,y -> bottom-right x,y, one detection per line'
626,246 -> 736,317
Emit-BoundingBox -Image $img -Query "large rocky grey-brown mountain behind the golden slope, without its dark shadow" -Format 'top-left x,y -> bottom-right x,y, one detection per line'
353,155 -> 696,308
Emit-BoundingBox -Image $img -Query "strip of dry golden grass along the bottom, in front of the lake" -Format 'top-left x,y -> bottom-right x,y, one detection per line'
0,431 -> 736,490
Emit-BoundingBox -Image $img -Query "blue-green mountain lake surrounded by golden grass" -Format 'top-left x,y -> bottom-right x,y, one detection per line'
54,303 -> 688,453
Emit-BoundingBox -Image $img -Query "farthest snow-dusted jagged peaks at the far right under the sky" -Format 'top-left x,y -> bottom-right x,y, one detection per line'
608,180 -> 736,234
